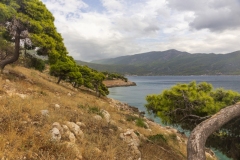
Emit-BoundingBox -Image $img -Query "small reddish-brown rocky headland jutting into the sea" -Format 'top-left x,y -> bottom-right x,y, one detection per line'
103,79 -> 136,88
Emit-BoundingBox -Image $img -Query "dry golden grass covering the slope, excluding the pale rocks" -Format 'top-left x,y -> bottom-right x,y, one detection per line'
0,66 -> 216,160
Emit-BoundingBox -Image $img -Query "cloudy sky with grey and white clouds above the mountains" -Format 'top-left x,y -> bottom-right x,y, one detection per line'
42,0 -> 240,61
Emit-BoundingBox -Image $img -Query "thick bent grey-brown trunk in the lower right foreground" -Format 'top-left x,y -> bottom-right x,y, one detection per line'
187,103 -> 240,160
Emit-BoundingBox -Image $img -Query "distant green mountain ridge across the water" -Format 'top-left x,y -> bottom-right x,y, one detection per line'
81,50 -> 240,75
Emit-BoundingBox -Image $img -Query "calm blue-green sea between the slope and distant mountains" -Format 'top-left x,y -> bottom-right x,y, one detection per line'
108,75 -> 240,160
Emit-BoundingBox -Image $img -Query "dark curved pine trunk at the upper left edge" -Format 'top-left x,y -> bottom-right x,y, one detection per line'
0,29 -> 21,72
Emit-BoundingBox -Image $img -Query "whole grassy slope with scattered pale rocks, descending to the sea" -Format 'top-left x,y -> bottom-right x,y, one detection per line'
0,67 -> 216,160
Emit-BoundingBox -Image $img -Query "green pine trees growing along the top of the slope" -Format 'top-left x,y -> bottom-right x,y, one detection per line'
0,0 -> 109,96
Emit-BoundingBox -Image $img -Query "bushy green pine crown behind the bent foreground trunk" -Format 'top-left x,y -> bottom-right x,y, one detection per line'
145,81 -> 240,159
